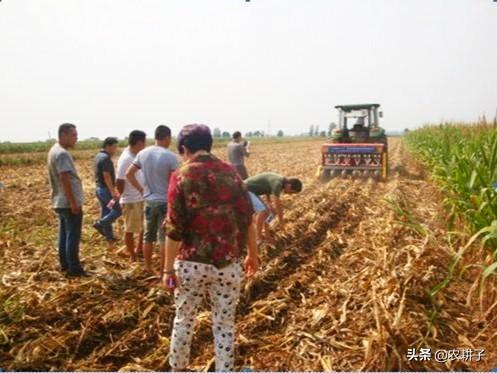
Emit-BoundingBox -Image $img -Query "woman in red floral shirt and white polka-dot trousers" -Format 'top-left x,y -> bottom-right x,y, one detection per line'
163,124 -> 258,371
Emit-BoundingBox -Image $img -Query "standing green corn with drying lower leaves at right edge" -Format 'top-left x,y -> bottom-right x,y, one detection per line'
406,120 -> 497,316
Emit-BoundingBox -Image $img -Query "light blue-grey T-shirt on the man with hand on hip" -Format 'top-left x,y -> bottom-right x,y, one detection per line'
133,145 -> 178,203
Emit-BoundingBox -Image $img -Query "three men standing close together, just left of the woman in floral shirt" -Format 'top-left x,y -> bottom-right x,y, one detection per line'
93,126 -> 179,273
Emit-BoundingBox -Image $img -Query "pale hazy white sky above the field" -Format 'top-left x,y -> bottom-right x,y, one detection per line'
0,0 -> 497,142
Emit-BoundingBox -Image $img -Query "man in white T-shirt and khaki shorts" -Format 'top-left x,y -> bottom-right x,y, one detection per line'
116,130 -> 146,261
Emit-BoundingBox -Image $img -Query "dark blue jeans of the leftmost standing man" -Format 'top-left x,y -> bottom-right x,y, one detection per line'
55,208 -> 83,273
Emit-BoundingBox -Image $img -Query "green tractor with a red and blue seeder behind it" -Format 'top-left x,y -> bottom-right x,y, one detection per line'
317,104 -> 388,181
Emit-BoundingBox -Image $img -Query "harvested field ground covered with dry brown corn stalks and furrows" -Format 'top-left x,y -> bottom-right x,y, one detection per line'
0,138 -> 497,370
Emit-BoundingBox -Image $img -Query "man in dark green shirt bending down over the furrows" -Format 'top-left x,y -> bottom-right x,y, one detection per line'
245,172 -> 302,240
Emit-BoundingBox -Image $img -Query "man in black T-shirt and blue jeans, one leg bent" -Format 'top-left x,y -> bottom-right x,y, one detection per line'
93,137 -> 121,249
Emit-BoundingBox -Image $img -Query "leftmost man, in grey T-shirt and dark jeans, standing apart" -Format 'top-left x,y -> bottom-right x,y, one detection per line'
48,123 -> 87,277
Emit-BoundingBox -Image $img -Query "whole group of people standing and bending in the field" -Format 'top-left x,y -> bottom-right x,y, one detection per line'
48,123 -> 302,371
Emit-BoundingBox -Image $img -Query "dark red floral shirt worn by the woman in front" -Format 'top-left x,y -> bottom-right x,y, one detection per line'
166,154 -> 254,268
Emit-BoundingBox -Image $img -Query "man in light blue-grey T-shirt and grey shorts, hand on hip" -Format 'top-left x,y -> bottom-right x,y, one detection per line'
126,125 -> 178,276
